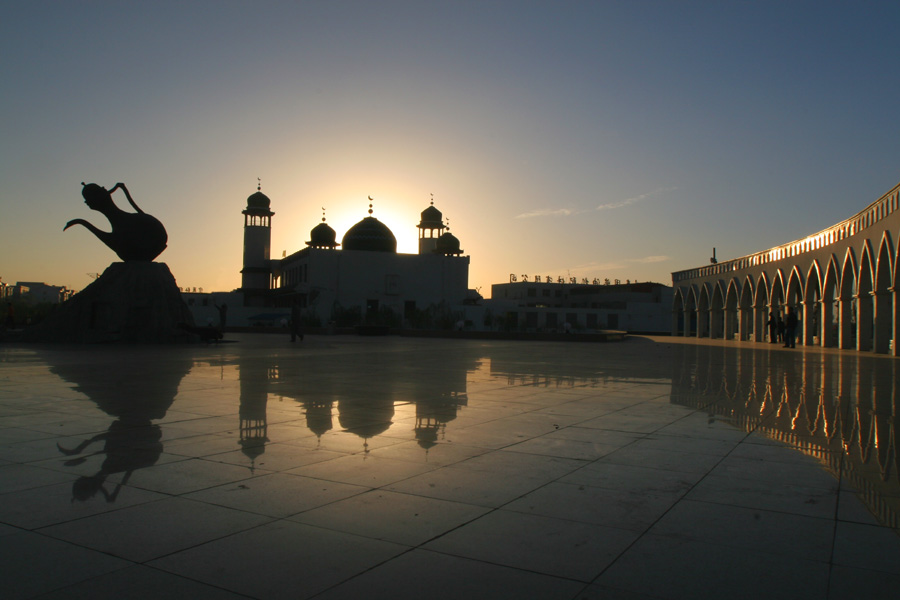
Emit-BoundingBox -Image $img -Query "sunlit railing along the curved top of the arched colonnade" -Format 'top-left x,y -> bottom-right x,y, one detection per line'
672,184 -> 900,283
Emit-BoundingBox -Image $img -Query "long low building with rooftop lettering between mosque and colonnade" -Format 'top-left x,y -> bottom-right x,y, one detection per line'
489,281 -> 672,333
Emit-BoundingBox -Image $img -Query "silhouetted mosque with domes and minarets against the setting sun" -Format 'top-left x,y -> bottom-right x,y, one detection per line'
235,187 -> 480,326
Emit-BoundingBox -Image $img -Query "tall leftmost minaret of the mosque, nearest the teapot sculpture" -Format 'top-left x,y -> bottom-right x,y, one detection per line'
241,180 -> 275,306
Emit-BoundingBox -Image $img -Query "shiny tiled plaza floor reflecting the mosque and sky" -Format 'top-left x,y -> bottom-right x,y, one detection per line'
0,335 -> 900,600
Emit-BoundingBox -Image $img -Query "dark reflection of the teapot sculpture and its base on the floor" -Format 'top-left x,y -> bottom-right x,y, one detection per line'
45,349 -> 191,502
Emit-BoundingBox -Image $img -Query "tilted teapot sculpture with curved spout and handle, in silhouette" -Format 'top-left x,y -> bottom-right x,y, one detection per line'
63,182 -> 168,261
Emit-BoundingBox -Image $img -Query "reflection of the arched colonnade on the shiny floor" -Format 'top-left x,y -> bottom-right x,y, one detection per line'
672,346 -> 900,528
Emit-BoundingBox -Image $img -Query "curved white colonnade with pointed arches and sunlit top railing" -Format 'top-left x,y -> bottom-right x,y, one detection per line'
672,180 -> 900,356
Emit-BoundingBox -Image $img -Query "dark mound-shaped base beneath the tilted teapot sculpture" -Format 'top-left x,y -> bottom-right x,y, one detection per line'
22,262 -> 196,343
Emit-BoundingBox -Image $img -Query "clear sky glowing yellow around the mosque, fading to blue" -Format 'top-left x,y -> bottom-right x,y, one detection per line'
0,0 -> 900,297
